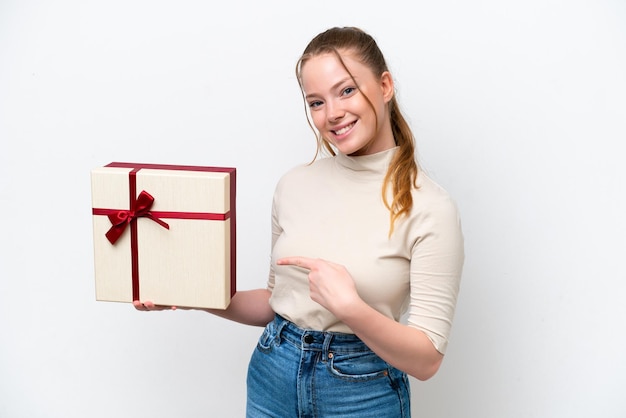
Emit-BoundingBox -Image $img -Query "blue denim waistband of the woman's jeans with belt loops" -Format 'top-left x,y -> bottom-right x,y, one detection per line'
274,314 -> 371,353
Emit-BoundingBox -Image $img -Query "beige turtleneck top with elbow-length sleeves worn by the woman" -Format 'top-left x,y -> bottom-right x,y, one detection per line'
268,148 -> 464,353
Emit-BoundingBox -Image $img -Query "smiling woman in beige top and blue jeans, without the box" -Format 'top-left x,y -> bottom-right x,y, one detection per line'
135,28 -> 464,418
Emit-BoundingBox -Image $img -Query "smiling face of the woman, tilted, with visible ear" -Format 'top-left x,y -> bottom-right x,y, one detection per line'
301,51 -> 395,155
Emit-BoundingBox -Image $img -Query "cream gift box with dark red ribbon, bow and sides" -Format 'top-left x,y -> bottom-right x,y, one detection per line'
91,163 -> 236,309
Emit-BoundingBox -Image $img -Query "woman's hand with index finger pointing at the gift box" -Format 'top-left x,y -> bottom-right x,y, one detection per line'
277,257 -> 361,318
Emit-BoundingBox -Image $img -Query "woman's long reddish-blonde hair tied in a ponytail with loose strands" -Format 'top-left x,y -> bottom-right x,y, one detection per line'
296,27 -> 418,236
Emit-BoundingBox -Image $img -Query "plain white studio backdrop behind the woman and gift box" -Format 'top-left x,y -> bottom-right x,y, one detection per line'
0,0 -> 626,418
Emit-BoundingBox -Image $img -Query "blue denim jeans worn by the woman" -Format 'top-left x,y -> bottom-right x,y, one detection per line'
246,315 -> 411,418
